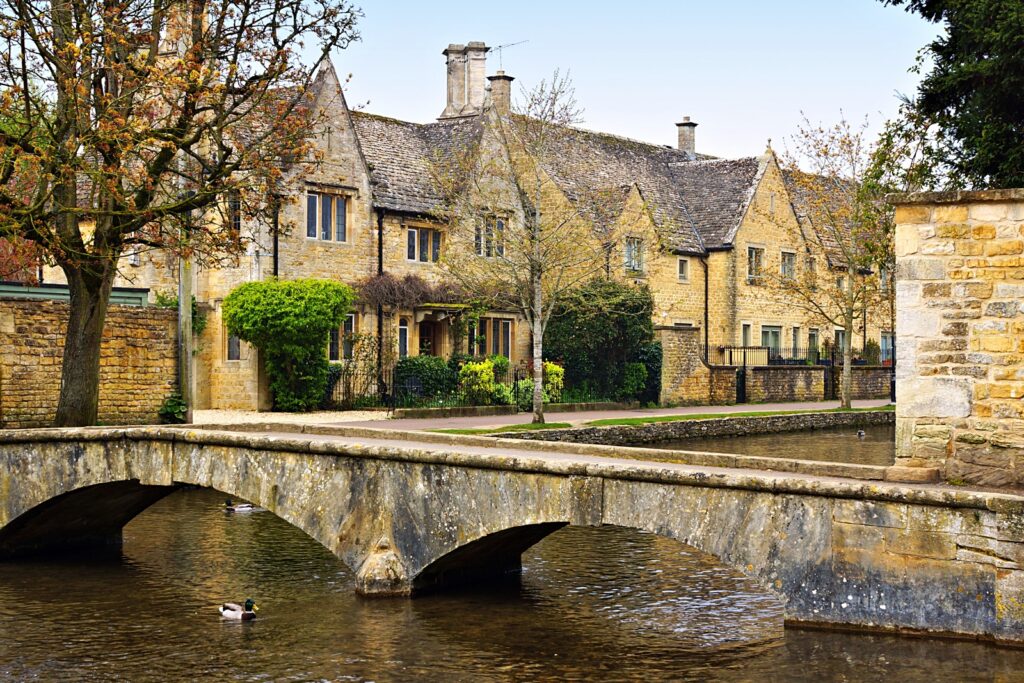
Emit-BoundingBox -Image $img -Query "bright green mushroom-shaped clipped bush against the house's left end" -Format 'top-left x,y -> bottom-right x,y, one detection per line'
222,280 -> 355,413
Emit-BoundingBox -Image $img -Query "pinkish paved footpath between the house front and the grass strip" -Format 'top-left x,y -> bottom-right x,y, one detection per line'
325,399 -> 889,430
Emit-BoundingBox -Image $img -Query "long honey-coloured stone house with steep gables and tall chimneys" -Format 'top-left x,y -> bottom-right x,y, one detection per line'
36,42 -> 880,410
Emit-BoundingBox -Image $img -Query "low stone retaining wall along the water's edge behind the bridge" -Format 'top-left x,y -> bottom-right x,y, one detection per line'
501,411 -> 896,445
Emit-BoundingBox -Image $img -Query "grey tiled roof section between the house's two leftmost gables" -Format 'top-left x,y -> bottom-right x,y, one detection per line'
351,112 -> 483,214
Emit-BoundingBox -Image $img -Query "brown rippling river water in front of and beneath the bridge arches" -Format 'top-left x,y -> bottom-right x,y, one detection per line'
0,489 -> 1024,683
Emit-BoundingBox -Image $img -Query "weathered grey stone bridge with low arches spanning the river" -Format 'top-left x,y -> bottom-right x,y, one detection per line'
0,428 -> 1024,644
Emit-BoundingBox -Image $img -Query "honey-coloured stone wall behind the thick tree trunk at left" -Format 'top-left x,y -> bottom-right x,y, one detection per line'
0,299 -> 177,429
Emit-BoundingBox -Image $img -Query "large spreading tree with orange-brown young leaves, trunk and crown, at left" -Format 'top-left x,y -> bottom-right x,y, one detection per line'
0,0 -> 358,426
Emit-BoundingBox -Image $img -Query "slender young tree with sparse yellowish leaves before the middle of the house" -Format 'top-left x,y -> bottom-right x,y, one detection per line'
434,72 -> 608,423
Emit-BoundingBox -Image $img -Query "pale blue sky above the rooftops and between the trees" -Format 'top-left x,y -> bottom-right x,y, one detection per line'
335,0 -> 939,157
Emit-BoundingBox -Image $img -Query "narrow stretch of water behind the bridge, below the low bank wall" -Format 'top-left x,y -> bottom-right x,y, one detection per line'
636,425 -> 896,465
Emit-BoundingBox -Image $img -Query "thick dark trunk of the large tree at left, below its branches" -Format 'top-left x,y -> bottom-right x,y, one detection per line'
54,266 -> 115,427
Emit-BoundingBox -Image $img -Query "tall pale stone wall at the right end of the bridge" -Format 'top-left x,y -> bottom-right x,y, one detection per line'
894,189 -> 1024,486
